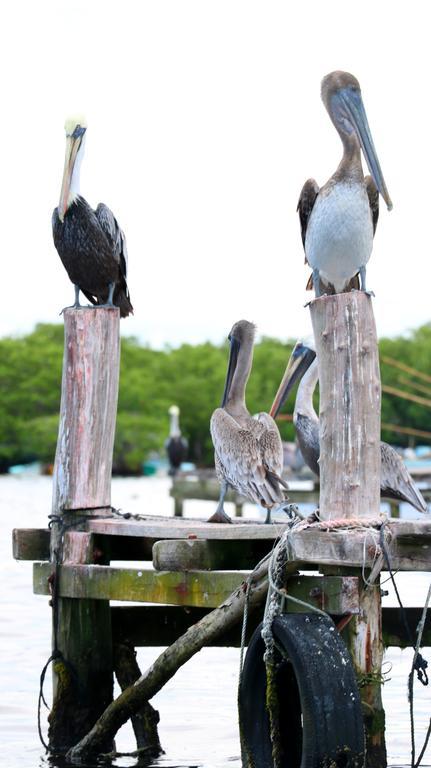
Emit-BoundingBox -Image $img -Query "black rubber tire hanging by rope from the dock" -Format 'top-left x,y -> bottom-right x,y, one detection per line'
238,613 -> 365,768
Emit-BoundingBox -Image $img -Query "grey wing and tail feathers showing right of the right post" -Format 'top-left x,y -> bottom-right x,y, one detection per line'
380,442 -> 427,512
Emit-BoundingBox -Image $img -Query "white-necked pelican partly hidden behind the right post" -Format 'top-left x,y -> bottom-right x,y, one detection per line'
270,342 -> 427,512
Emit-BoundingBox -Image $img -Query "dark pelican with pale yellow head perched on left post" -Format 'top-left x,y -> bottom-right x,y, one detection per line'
52,120 -> 133,317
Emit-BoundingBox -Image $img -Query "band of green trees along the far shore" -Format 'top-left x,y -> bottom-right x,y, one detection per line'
0,323 -> 431,473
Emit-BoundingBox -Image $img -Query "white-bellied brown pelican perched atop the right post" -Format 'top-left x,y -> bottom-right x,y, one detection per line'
297,72 -> 392,296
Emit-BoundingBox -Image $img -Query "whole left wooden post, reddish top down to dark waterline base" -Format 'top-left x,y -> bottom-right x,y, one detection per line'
49,308 -> 120,751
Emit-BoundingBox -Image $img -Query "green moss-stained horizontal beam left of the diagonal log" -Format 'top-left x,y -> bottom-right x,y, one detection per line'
33,563 -> 247,608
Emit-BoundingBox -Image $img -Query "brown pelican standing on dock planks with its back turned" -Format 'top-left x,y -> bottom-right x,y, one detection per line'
210,320 -> 287,523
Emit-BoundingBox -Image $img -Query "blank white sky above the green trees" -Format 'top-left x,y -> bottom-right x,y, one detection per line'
0,0 -> 431,347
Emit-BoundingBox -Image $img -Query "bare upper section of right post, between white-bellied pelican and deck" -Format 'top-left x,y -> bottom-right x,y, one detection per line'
310,291 -> 381,520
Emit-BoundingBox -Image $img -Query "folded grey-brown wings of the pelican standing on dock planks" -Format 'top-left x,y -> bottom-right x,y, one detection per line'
210,408 -> 283,507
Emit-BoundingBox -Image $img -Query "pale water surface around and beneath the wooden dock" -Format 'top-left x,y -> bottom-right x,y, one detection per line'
0,476 -> 431,768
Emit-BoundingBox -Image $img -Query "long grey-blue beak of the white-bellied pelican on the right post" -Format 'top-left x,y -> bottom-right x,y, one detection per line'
337,88 -> 392,211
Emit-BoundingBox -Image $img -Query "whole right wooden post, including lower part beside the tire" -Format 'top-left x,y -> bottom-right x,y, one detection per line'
310,291 -> 386,768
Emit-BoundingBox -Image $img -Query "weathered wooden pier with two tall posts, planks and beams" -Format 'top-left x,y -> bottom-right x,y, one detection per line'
13,292 -> 431,768
